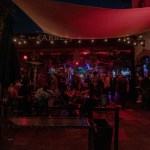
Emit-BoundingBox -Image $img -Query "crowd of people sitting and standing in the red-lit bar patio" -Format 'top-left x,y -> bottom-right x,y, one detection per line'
2,68 -> 150,116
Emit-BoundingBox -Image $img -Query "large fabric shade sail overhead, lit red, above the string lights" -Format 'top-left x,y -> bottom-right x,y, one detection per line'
12,0 -> 150,39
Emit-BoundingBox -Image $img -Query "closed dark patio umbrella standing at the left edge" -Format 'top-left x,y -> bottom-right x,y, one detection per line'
0,13 -> 20,87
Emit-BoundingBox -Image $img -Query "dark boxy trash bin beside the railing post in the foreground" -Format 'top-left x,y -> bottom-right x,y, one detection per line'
94,119 -> 113,150
